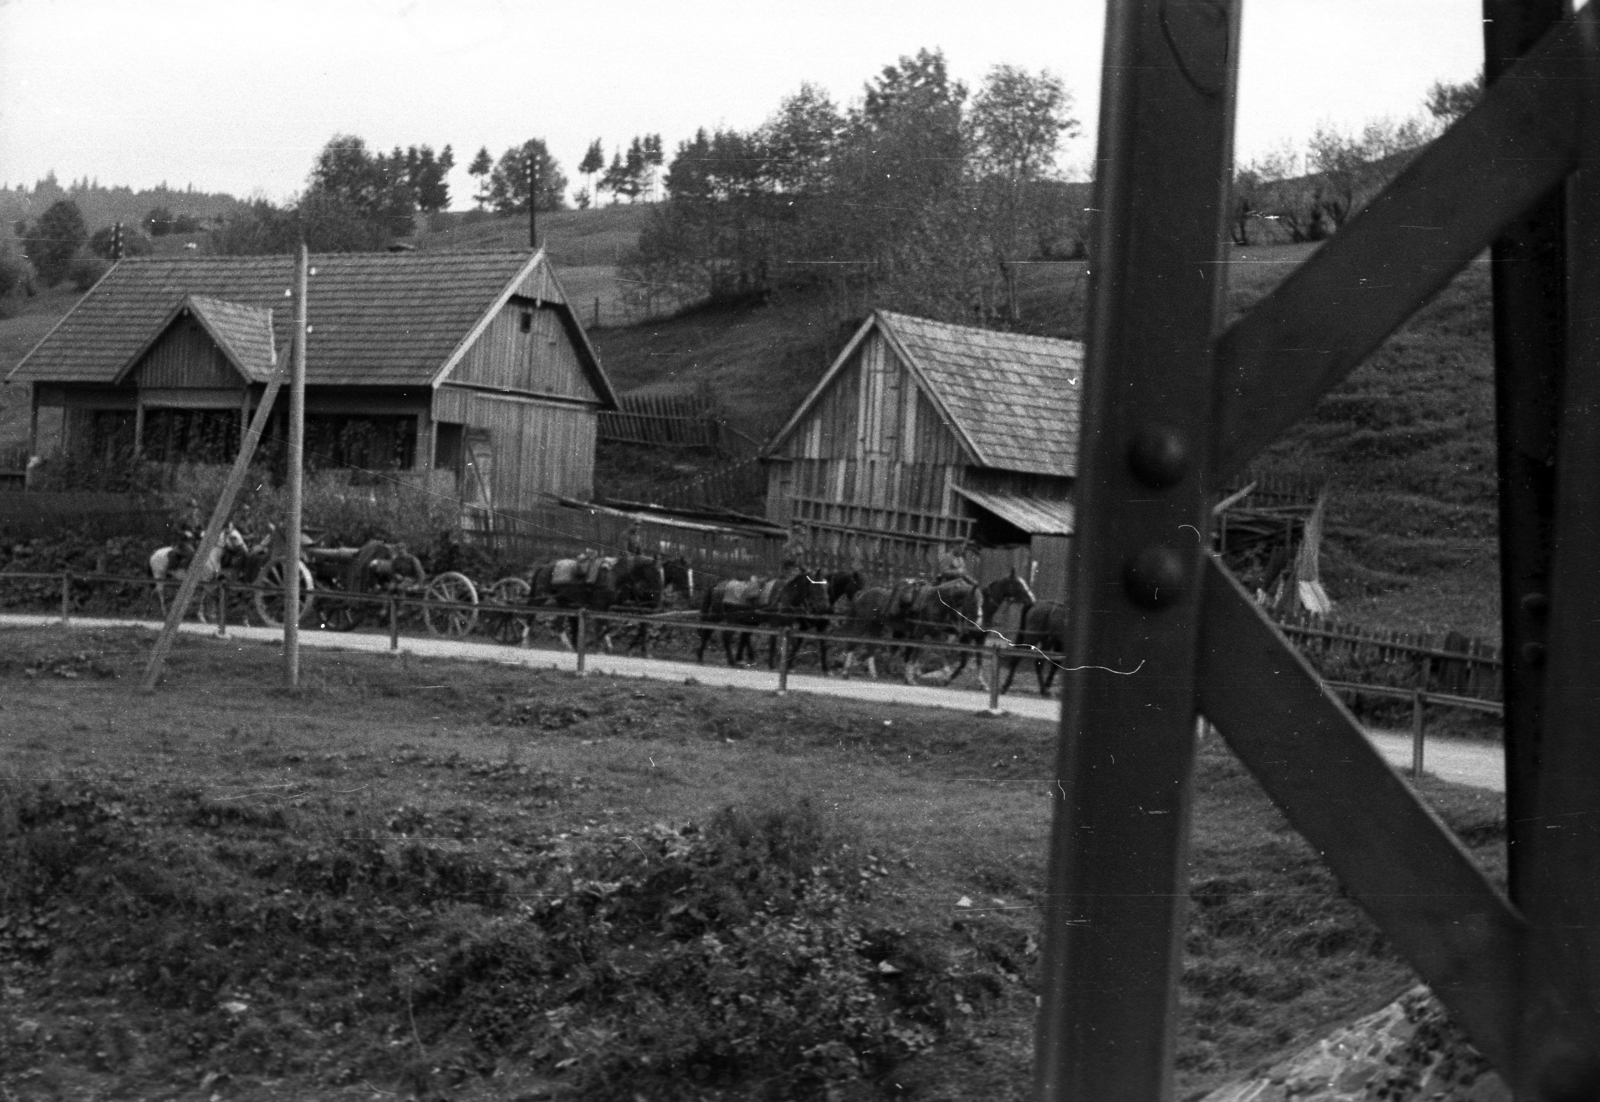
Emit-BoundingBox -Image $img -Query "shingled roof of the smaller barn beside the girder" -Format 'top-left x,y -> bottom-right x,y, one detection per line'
768,310 -> 1083,477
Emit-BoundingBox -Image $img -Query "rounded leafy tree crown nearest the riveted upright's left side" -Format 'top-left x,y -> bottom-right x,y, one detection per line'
970,66 -> 1078,184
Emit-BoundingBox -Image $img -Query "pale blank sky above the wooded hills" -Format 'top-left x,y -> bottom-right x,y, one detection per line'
0,0 -> 1482,210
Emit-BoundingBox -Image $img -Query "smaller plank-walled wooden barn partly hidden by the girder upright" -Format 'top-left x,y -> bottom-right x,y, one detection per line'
763,310 -> 1083,598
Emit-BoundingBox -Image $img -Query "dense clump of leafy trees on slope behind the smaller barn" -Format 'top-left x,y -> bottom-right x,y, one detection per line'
626,50 -> 1085,320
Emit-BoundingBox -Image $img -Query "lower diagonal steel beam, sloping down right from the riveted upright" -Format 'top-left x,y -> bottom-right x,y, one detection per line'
1200,558 -> 1523,1067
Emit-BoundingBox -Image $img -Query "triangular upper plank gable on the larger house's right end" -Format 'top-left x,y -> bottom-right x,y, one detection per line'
450,296 -> 600,405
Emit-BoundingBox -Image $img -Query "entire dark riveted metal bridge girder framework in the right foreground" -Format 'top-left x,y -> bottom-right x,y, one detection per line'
1037,0 -> 1600,1102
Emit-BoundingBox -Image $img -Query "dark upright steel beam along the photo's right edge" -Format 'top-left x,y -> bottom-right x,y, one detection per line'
1515,10 -> 1600,1102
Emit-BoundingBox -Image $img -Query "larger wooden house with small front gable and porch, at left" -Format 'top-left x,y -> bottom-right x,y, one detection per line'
6,251 -> 616,526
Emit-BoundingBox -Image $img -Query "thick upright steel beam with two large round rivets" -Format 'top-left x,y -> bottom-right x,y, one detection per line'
1035,0 -> 1238,1102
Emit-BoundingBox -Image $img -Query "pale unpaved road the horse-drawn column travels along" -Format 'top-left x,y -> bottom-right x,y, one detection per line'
0,614 -> 1506,792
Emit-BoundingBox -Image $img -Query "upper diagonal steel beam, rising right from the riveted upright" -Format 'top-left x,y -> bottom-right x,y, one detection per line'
1216,8 -> 1579,486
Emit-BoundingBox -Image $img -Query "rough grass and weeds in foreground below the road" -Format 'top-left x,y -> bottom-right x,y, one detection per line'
0,629 -> 1504,1099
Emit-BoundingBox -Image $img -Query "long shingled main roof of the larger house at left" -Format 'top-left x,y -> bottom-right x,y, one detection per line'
6,251 -> 614,405
